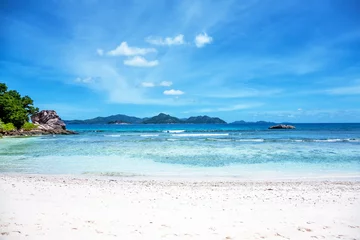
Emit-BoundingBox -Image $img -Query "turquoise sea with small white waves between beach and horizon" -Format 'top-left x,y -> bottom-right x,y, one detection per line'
0,124 -> 360,178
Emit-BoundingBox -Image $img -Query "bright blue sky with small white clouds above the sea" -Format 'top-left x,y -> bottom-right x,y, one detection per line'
0,0 -> 360,122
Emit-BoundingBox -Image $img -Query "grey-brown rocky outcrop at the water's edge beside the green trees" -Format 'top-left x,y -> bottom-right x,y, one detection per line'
0,110 -> 76,136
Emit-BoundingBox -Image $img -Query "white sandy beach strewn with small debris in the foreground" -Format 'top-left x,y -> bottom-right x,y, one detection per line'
0,174 -> 360,239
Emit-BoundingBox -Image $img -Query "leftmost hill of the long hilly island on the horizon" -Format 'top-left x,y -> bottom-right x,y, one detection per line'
64,114 -> 143,124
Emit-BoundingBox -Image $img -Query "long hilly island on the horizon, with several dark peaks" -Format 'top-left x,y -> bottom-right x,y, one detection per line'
65,113 -> 226,124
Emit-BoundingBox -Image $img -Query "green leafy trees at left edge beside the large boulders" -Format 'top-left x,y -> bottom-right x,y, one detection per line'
0,83 -> 39,128
